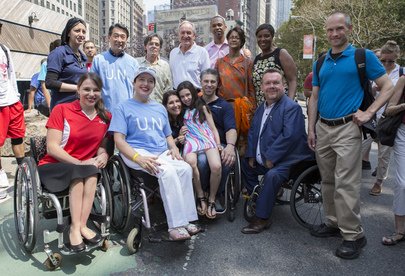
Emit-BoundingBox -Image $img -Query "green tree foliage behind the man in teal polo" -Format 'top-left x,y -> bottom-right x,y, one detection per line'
275,0 -> 405,92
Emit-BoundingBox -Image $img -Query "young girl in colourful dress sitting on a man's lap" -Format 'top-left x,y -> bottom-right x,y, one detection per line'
177,81 -> 222,219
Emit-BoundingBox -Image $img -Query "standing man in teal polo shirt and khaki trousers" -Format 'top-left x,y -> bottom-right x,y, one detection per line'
308,12 -> 392,259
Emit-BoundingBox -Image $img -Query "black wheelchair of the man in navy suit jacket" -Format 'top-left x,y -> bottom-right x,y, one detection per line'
243,160 -> 323,229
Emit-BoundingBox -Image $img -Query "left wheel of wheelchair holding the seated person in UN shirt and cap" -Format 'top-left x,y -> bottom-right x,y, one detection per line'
106,155 -> 131,233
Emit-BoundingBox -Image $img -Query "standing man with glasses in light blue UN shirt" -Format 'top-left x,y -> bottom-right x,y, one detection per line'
90,23 -> 139,111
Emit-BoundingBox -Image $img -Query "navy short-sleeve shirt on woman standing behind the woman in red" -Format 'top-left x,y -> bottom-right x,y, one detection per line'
47,45 -> 87,106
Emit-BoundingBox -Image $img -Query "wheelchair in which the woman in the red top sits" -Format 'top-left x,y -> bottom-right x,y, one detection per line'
14,137 -> 110,270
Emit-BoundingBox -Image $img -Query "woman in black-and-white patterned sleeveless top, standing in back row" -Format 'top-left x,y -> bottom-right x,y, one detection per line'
253,23 -> 297,105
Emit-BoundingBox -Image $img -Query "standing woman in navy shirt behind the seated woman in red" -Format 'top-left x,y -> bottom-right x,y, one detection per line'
46,17 -> 87,110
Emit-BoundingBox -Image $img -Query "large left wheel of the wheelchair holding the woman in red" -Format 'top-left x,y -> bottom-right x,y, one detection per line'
14,157 -> 40,253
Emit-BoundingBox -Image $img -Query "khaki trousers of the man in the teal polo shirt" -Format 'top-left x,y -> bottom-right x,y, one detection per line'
316,121 -> 364,240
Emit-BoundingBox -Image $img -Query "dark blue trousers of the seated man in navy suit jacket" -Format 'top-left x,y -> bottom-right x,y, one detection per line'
242,158 -> 290,219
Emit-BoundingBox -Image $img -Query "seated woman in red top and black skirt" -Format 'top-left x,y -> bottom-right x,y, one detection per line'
38,73 -> 111,252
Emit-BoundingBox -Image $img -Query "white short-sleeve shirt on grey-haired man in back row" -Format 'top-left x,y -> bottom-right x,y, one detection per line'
169,43 -> 210,88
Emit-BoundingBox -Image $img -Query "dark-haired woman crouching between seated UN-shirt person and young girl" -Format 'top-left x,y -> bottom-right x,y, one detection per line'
162,90 -> 187,151
